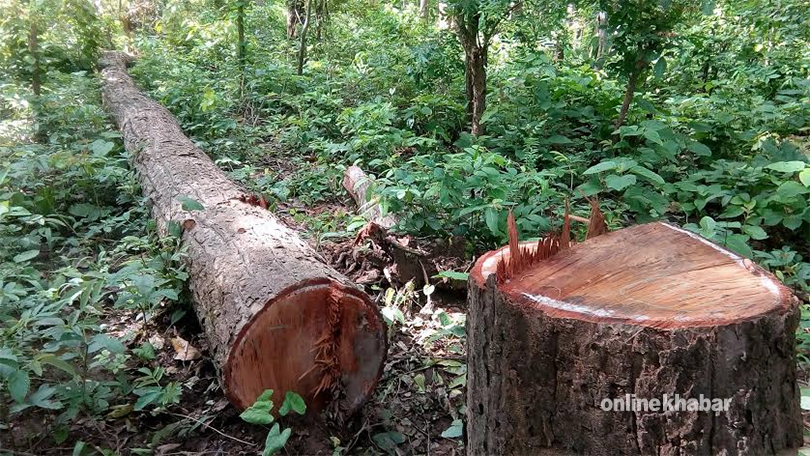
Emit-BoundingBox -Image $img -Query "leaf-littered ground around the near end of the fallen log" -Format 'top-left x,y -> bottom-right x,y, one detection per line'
7,146 -> 466,456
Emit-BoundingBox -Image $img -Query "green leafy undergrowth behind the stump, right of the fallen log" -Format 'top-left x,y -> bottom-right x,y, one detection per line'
128,3 -> 810,293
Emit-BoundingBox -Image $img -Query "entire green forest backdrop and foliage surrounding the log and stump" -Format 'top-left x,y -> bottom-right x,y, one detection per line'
0,0 -> 810,454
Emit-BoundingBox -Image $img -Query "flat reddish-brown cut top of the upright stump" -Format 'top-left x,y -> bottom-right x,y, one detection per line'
471,223 -> 795,329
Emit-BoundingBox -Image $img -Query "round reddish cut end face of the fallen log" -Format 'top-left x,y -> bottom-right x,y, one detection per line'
223,280 -> 387,415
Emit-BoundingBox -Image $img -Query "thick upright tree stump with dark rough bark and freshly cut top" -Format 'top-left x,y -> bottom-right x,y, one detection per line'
467,223 -> 802,456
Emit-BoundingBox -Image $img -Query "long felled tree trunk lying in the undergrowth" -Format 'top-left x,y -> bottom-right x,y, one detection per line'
100,53 -> 386,416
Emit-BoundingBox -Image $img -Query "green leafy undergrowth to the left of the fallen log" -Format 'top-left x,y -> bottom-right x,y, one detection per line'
0,66 -> 188,454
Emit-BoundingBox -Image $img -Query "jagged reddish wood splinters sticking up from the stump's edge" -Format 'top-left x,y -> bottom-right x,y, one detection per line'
495,197 -> 608,283
